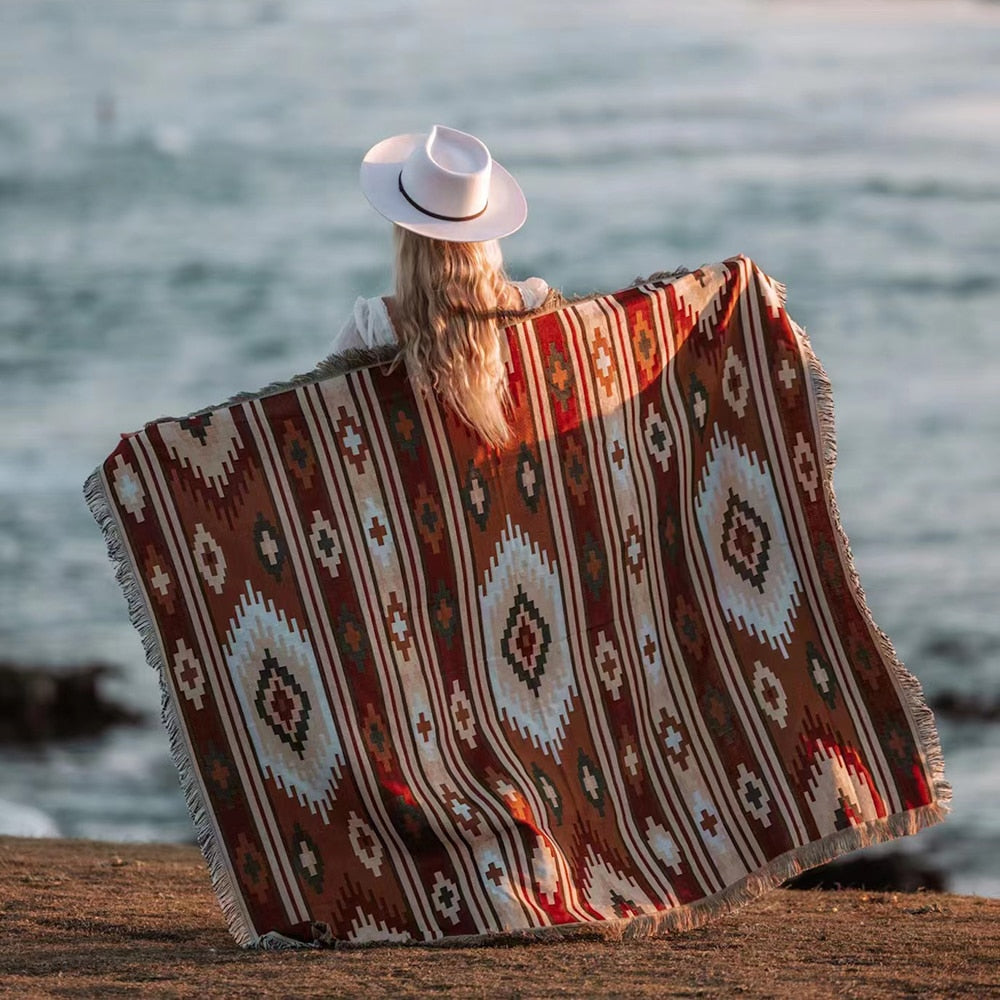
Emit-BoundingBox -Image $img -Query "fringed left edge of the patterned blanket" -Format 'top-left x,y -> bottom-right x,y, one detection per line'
83,469 -> 261,947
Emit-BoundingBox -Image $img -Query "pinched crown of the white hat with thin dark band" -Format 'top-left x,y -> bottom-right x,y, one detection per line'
399,125 -> 493,221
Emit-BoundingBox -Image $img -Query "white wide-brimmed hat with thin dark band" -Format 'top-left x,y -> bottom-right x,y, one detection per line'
361,125 -> 528,243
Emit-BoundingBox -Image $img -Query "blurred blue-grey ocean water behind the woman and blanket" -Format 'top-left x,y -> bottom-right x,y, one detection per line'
0,0 -> 1000,895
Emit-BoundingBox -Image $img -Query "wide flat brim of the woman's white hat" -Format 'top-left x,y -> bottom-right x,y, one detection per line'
361,134 -> 528,243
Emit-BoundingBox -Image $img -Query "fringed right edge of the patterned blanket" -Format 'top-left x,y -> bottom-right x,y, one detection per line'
780,296 -> 952,820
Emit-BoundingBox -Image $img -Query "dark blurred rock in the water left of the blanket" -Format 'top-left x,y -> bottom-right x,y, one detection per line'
0,661 -> 142,743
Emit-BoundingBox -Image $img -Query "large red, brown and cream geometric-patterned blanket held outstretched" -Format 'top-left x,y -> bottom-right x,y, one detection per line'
87,258 -> 949,945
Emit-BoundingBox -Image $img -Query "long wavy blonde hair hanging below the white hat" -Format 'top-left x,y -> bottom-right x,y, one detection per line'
393,226 -> 524,446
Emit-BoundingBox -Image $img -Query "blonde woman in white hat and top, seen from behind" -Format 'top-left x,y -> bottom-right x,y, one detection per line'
331,125 -> 549,445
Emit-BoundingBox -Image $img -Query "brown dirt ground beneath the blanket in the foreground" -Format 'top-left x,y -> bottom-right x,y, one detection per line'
0,838 -> 1000,1000
